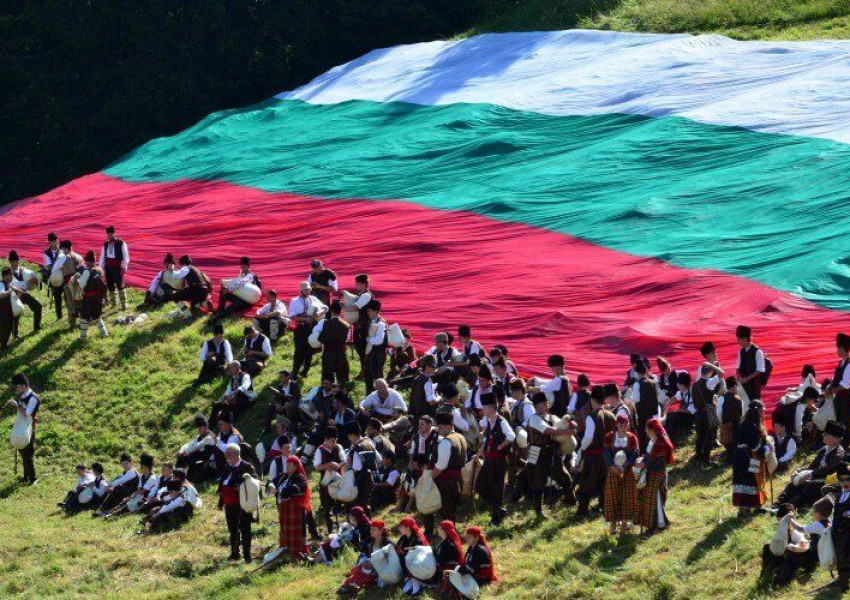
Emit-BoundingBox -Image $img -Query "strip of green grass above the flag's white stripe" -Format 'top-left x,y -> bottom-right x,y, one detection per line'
470,0 -> 850,40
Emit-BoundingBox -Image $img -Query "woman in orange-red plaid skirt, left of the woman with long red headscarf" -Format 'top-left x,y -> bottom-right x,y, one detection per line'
603,414 -> 639,535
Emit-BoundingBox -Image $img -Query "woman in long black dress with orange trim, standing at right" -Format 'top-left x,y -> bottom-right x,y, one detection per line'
732,400 -> 767,516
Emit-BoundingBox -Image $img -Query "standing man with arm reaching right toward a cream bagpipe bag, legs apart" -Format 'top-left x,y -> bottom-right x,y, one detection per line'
525,392 -> 575,517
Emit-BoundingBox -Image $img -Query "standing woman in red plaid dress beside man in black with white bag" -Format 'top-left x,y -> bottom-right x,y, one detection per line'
277,456 -> 310,559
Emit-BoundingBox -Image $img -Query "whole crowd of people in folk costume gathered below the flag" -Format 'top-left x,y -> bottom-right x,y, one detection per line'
0,227 -> 850,597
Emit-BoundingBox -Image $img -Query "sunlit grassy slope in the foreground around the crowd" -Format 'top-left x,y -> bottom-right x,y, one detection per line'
0,274 -> 832,600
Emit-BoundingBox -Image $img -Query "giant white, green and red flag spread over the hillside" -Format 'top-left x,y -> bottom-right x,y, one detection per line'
0,31 -> 850,408
